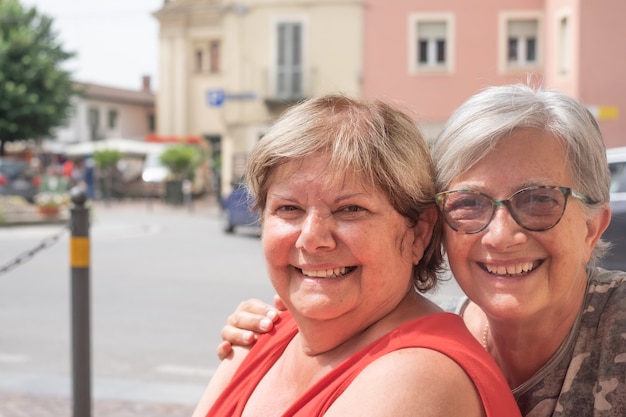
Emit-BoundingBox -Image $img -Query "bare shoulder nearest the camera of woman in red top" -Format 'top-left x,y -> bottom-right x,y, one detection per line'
325,348 -> 484,417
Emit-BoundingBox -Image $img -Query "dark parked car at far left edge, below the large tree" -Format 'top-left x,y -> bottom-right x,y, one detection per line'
0,158 -> 40,203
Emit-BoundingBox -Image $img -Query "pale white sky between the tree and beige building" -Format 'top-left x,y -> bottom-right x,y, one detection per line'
20,0 -> 163,90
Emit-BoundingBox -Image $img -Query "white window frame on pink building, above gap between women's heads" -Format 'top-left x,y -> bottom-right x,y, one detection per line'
407,13 -> 456,75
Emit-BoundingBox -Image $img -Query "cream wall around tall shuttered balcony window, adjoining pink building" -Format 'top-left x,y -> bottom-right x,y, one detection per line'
222,0 -> 362,185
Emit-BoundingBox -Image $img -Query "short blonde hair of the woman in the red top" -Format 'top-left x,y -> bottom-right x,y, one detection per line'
246,95 -> 442,291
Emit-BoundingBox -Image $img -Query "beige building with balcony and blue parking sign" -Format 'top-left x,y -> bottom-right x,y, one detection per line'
154,0 -> 364,195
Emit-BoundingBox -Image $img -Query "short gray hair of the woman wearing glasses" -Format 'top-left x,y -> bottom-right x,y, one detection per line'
432,84 -> 610,264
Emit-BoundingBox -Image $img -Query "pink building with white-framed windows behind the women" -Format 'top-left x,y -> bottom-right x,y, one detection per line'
363,0 -> 626,147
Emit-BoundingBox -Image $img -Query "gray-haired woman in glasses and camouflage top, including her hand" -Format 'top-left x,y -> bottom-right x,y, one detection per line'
218,85 -> 626,417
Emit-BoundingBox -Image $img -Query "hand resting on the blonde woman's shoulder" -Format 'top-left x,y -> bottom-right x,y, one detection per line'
217,296 -> 285,360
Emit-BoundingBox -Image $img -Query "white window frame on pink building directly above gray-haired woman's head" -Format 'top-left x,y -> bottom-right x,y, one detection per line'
498,10 -> 543,74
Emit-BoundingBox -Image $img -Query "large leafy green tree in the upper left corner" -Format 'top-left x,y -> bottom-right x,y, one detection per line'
0,0 -> 78,155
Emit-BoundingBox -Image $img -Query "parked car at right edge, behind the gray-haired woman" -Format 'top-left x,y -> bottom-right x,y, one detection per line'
601,147 -> 626,271
